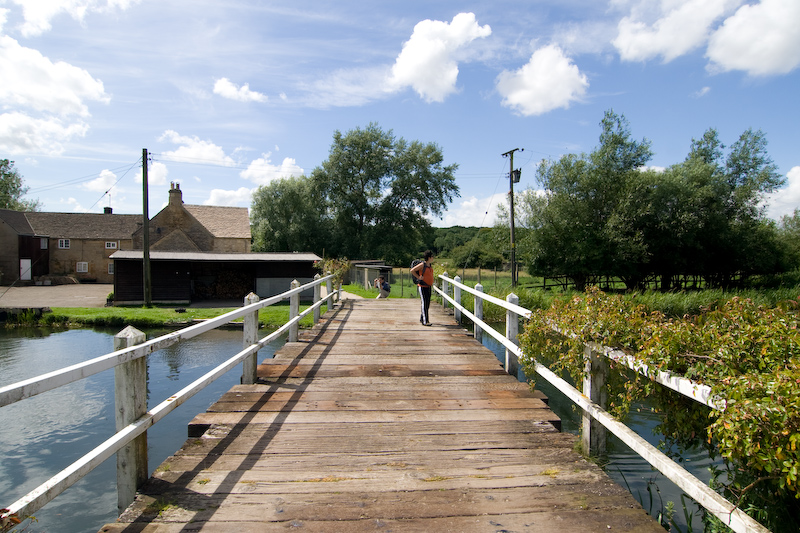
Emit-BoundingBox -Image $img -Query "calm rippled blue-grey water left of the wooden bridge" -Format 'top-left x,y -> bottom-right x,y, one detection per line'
0,328 -> 285,533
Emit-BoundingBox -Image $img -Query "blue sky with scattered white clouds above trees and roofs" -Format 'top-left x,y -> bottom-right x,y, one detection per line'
0,0 -> 800,226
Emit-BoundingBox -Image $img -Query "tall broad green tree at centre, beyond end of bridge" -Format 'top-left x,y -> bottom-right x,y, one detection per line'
311,123 -> 458,264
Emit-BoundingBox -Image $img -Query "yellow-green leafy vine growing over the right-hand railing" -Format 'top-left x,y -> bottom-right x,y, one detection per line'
520,289 -> 800,531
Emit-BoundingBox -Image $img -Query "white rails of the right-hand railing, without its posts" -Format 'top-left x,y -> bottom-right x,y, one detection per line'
434,276 -> 769,533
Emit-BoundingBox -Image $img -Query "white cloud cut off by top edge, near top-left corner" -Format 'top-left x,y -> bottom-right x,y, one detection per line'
11,0 -> 138,37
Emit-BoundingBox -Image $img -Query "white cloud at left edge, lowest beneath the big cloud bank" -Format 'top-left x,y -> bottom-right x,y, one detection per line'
0,113 -> 89,155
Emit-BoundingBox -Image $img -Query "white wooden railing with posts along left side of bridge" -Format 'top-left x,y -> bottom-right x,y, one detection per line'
0,275 -> 341,531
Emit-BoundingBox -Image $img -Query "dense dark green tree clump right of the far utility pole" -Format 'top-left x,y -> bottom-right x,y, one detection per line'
521,111 -> 785,289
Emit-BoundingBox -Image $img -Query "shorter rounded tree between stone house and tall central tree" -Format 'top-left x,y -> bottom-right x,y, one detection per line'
250,176 -> 328,255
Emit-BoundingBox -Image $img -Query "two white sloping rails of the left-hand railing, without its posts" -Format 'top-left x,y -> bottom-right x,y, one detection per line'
0,275 -> 336,530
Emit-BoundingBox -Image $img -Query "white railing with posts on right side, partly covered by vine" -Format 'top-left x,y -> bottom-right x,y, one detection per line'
434,273 -> 769,533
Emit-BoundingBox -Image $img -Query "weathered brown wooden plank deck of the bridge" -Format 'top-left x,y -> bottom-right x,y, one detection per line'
101,299 -> 664,533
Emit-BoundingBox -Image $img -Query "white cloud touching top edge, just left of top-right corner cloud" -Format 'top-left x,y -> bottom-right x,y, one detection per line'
612,0 -> 740,62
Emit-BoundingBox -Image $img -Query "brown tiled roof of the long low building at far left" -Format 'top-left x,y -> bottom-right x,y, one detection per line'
25,212 -> 142,239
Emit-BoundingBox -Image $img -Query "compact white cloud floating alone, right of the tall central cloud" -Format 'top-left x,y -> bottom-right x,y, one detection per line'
497,45 -> 589,116
